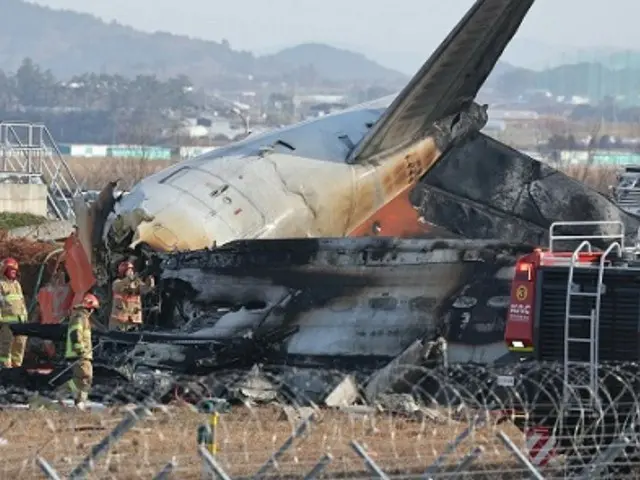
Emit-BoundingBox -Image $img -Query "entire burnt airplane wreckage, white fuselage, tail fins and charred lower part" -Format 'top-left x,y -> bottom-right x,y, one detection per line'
3,0 -> 640,406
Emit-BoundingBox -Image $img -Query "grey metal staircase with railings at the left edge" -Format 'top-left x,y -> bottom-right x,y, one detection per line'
0,122 -> 80,220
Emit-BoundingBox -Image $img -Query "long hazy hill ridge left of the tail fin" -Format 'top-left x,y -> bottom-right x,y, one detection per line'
0,0 -> 404,83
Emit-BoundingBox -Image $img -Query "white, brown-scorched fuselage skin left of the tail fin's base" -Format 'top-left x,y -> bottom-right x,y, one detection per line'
105,96 -> 410,251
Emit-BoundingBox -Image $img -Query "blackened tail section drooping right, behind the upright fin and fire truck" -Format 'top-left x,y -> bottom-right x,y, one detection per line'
411,134 -> 640,245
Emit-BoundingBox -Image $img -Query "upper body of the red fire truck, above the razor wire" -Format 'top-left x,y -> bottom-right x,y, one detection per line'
505,222 -> 640,369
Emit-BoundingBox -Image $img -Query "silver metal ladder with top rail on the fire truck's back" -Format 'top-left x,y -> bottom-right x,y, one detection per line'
549,221 -> 625,410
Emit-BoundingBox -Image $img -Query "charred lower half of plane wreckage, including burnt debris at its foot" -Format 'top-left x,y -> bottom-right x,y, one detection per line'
7,238 -> 533,404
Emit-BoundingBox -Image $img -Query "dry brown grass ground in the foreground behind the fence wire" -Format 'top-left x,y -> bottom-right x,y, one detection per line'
0,406 -> 522,480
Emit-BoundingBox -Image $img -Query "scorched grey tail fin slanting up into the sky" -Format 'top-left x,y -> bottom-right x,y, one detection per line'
348,0 -> 533,163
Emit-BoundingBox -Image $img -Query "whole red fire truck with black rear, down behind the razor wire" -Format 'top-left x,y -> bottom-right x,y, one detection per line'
505,222 -> 640,468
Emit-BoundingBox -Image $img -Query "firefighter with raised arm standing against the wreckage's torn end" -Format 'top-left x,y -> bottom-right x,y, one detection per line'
109,262 -> 155,330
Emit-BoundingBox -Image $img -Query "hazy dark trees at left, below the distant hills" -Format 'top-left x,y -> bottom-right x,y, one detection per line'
0,58 -> 198,143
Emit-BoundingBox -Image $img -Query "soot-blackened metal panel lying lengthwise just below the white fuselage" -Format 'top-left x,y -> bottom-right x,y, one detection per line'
142,238 -> 531,363
